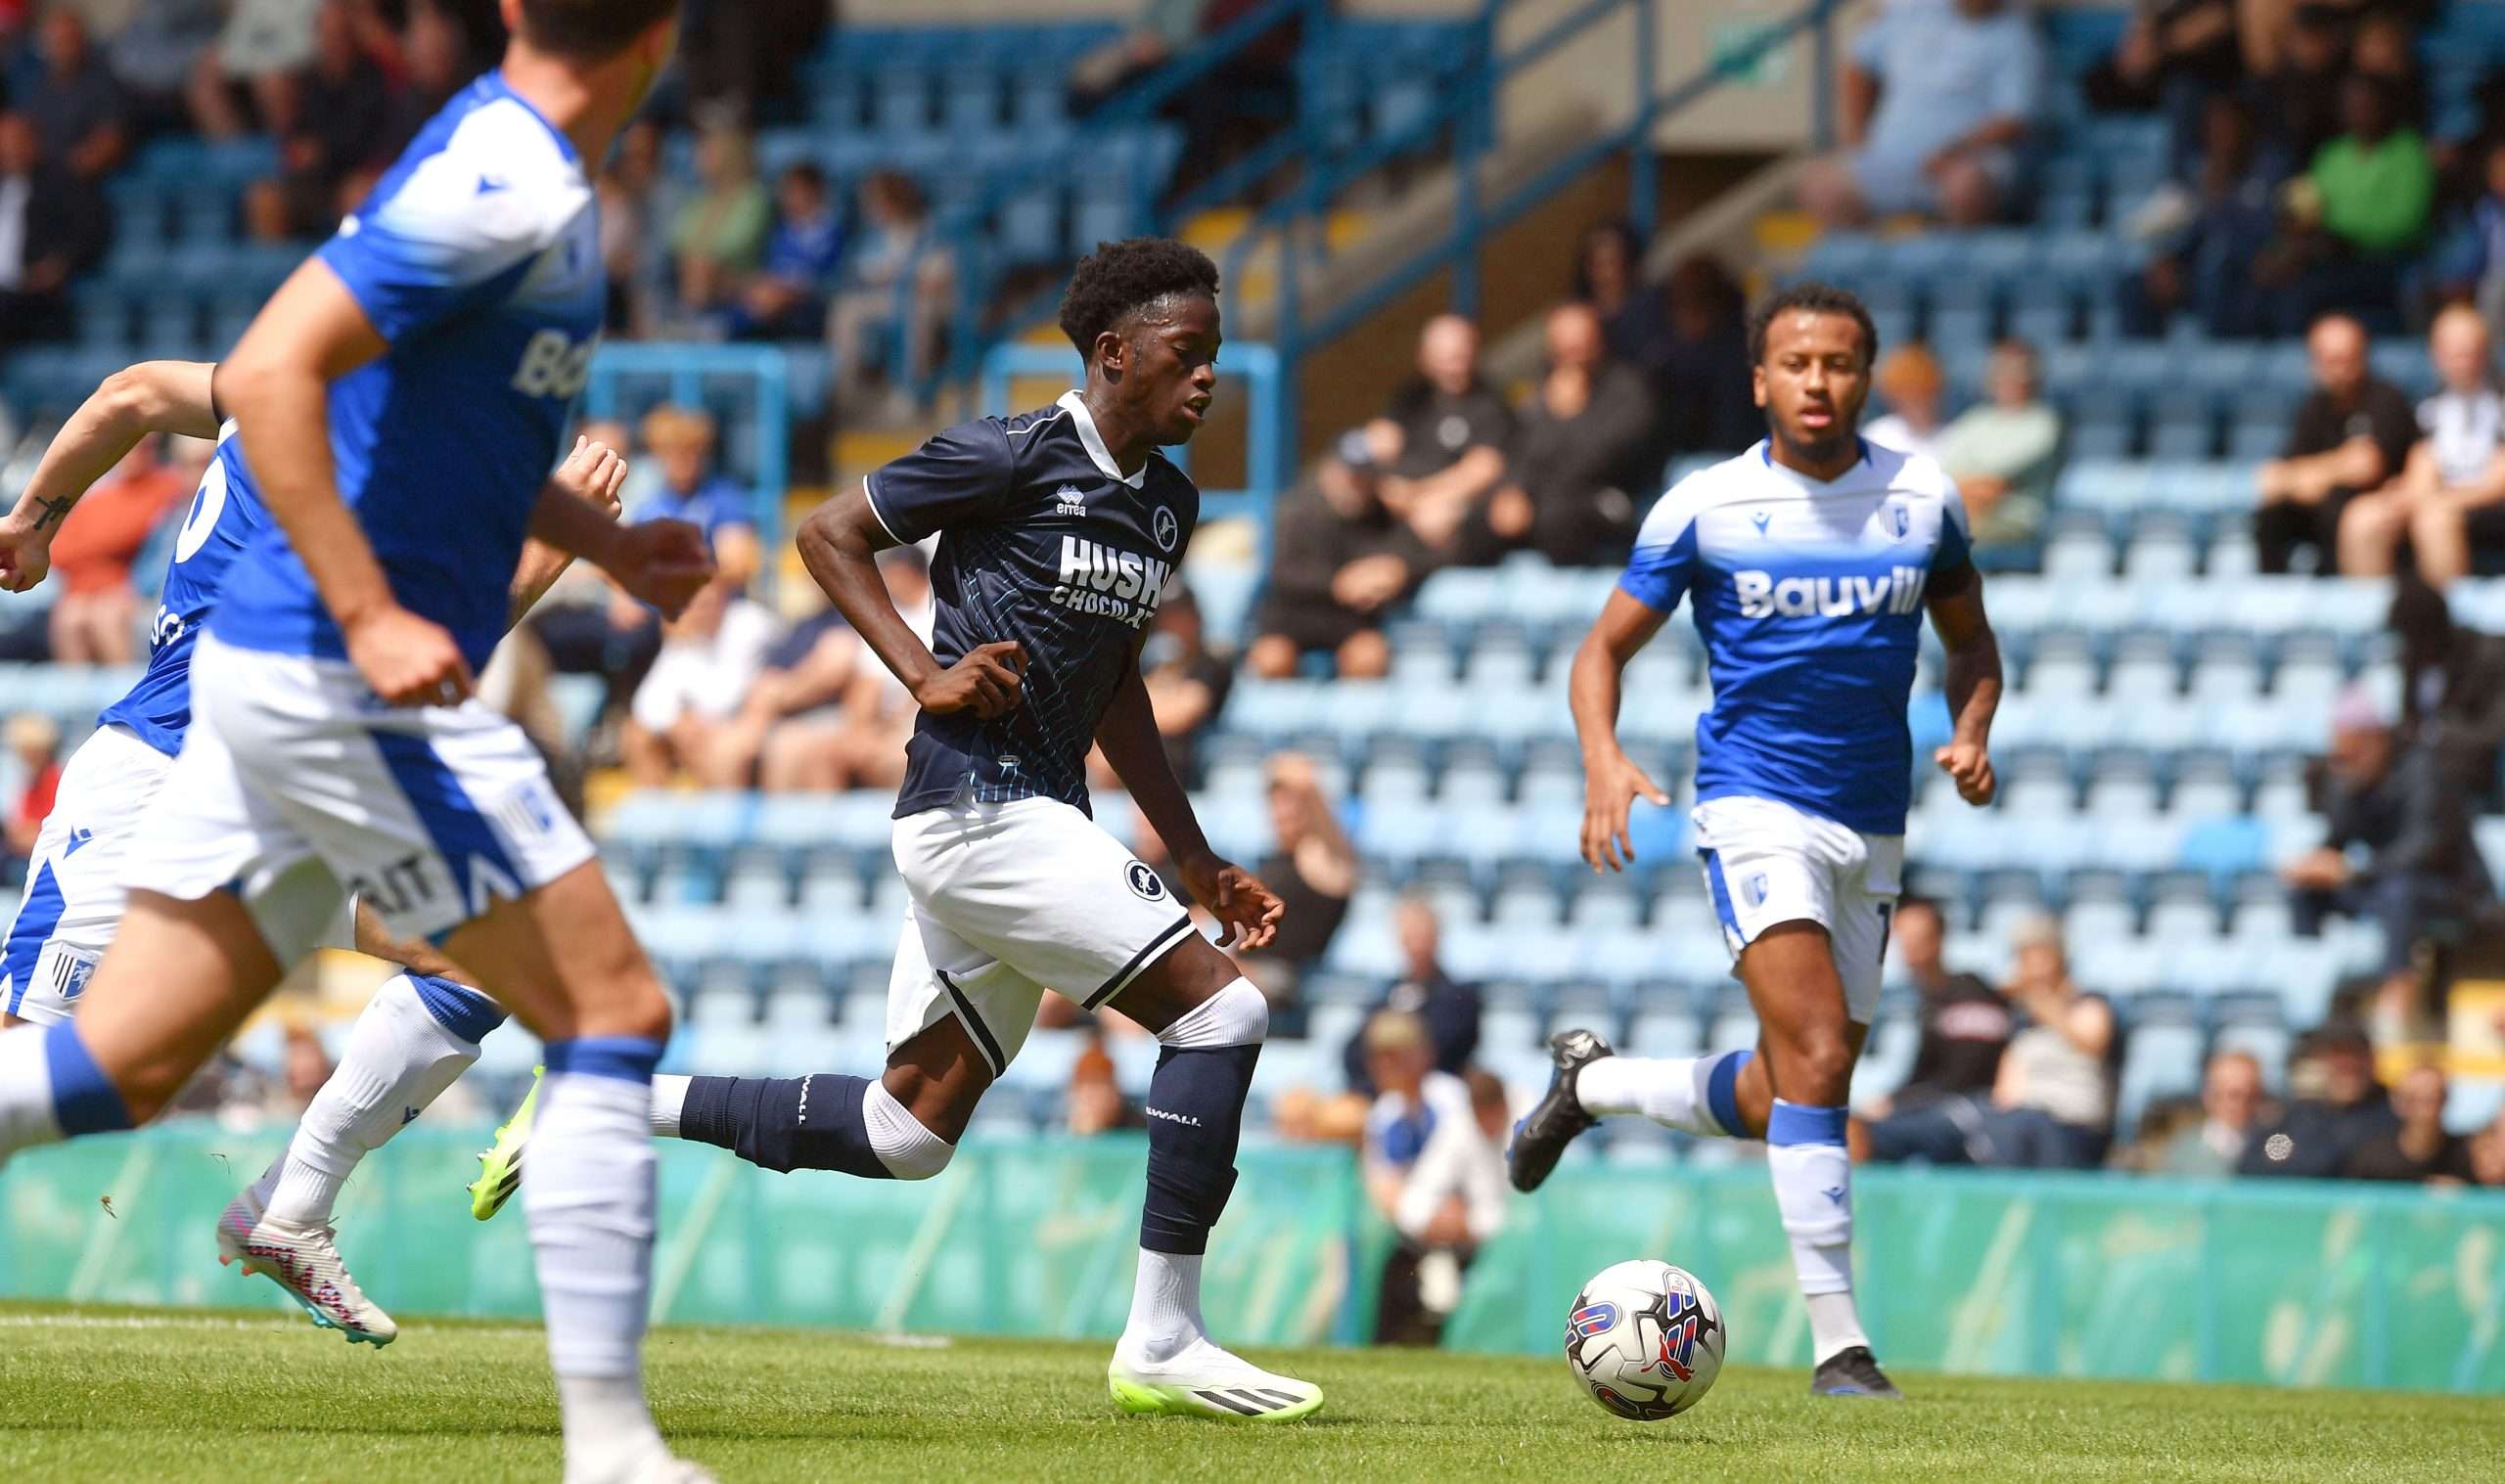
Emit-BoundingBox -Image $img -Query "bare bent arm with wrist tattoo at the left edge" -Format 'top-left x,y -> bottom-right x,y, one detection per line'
0,360 -> 218,593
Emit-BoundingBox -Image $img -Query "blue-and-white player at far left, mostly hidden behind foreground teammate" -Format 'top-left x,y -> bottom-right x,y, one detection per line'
0,360 -> 626,1344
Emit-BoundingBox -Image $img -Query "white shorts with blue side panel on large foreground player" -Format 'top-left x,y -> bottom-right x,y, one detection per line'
122,636 -> 591,961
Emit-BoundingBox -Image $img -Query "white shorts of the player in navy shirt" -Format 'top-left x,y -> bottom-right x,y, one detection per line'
887,790 -> 1193,1076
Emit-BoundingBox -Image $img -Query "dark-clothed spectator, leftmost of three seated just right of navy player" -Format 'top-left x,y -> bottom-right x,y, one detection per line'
1245,427 -> 1435,681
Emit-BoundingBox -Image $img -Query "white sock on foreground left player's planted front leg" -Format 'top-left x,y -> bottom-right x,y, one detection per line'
521,1061 -> 661,1479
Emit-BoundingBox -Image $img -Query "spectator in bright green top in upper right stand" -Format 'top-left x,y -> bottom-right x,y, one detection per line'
2262,75 -> 2435,328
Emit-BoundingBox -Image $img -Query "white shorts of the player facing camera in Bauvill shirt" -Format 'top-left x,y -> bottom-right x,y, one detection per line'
1691,798 -> 1904,1026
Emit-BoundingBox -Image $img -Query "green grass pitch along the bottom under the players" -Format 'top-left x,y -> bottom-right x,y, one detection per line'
0,1306 -> 2505,1484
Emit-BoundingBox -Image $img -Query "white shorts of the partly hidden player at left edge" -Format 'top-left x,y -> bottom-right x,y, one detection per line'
0,726 -> 356,1026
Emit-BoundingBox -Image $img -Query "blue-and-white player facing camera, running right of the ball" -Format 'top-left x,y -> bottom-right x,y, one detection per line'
1508,286 -> 2001,1396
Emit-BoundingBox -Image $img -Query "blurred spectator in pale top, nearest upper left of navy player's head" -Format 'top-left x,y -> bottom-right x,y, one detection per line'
827,170 -> 954,415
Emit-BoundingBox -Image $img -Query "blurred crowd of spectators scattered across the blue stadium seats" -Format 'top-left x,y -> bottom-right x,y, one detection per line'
15,0 -> 2505,1251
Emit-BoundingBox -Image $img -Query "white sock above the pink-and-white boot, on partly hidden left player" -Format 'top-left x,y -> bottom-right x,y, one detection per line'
255,973 -> 478,1227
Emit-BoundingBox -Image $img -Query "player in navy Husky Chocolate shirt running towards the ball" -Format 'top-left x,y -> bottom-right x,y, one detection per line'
476,238 -> 1323,1421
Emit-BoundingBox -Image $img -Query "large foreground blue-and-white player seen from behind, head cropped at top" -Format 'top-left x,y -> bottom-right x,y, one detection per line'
0,0 -> 711,1484
